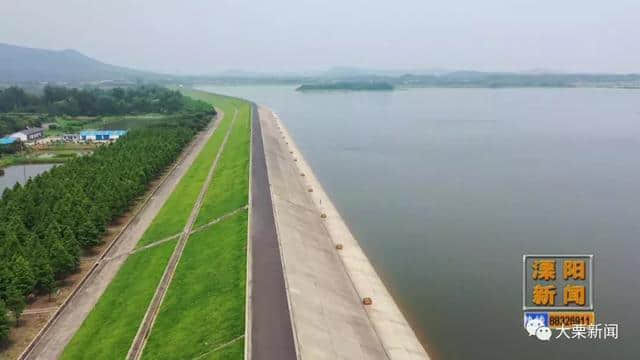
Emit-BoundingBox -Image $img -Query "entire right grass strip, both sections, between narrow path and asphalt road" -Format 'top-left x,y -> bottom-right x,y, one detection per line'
143,88 -> 251,359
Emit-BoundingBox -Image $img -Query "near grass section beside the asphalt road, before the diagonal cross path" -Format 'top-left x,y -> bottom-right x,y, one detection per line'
142,210 -> 248,360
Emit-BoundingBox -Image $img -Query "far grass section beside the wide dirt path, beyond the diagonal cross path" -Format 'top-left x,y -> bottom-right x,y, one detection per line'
137,105 -> 233,247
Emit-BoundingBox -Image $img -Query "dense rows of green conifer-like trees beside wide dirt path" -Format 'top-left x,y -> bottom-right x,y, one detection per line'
0,88 -> 214,341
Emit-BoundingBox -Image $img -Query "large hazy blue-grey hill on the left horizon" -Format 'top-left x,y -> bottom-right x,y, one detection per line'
0,43 -> 162,83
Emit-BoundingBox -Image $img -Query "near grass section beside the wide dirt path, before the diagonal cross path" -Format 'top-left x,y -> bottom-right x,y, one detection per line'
61,240 -> 177,360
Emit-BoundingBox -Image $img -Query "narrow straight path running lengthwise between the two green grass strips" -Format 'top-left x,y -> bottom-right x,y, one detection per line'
127,108 -> 238,360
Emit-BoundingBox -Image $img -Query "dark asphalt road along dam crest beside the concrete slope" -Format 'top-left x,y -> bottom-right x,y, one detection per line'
250,104 -> 296,360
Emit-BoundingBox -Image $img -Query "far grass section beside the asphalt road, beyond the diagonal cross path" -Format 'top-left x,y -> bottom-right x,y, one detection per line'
195,103 -> 251,226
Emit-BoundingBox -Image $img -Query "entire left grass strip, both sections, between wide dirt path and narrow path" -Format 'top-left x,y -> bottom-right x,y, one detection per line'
62,102 -> 230,359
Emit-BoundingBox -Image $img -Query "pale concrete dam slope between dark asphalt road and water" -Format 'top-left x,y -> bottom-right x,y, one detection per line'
253,106 -> 428,359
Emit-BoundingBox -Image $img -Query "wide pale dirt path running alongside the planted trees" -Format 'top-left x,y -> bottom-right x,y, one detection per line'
19,109 -> 224,360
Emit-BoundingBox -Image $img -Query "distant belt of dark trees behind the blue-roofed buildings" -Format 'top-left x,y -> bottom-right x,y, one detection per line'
0,86 -> 211,139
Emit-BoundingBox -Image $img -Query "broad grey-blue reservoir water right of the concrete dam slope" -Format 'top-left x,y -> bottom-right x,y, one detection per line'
202,86 -> 640,359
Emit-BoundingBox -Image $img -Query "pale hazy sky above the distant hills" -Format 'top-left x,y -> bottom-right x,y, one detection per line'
0,0 -> 640,74
